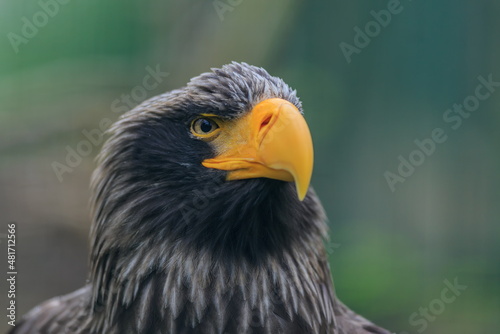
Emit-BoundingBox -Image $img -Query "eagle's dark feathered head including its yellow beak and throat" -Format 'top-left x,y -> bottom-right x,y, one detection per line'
92,62 -> 320,261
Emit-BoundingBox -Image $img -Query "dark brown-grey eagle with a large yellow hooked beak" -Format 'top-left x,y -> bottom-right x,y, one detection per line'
11,62 -> 390,334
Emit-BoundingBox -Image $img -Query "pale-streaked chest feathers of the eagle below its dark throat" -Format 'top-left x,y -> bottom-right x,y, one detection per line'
93,243 -> 334,334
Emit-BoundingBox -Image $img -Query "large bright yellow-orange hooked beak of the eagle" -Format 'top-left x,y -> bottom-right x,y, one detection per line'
203,98 -> 314,200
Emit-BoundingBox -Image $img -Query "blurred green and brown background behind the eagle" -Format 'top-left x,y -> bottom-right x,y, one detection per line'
0,0 -> 500,334
